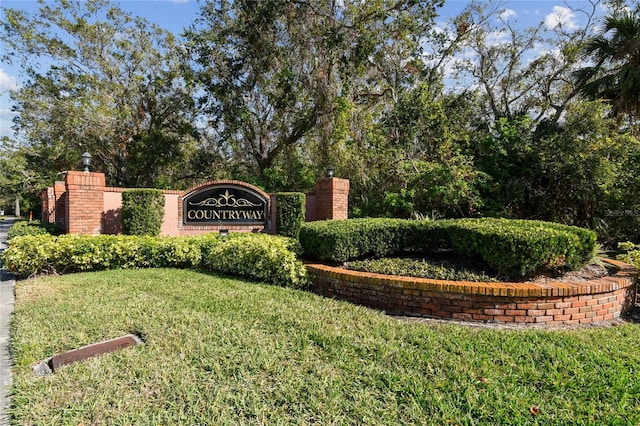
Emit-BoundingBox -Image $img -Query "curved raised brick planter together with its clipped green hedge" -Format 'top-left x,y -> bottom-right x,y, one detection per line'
301,219 -> 637,324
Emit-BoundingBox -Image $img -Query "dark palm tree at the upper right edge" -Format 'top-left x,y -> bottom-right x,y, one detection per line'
575,8 -> 640,129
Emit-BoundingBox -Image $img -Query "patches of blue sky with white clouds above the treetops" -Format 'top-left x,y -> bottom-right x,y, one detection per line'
0,0 -> 605,136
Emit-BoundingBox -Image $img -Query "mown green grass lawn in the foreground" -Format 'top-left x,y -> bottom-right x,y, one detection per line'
11,269 -> 640,425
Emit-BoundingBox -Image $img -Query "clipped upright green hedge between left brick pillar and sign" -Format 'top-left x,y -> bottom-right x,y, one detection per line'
122,189 -> 164,237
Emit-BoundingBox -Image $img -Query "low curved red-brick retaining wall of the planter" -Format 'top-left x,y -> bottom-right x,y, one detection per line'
307,259 -> 638,324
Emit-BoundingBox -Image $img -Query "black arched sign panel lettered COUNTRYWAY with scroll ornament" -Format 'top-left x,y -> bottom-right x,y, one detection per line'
182,184 -> 269,225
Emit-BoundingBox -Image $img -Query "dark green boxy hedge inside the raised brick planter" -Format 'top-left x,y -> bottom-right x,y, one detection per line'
300,218 -> 596,276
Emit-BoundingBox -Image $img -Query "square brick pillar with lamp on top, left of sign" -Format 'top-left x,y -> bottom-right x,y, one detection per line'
65,171 -> 106,235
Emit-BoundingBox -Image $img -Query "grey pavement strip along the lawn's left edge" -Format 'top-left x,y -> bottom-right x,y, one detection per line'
0,218 -> 15,426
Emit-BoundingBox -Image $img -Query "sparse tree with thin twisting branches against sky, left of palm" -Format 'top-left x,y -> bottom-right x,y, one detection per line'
456,0 -> 598,128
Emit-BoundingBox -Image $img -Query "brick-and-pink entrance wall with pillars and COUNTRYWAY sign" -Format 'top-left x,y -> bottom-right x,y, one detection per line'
40,170 -> 349,236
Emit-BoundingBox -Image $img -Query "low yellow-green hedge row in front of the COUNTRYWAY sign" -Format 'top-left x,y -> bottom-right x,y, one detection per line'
2,234 -> 307,288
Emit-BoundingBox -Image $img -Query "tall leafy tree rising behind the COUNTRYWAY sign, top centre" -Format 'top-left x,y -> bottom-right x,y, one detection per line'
186,0 -> 441,188
